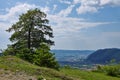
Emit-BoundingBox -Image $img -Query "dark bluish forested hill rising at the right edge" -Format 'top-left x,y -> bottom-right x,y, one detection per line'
86,48 -> 120,64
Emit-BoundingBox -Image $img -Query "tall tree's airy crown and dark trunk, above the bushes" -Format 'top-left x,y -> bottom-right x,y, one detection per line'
7,9 -> 54,49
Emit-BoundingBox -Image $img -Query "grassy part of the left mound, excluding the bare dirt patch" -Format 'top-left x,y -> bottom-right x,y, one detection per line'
0,56 -> 73,80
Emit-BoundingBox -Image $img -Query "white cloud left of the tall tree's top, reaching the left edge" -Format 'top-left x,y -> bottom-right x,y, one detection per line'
0,3 -> 36,23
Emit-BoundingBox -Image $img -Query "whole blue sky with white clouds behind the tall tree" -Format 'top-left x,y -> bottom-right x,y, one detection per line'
0,0 -> 120,50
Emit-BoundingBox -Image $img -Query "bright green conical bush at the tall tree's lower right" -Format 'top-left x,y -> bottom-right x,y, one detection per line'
33,44 -> 59,70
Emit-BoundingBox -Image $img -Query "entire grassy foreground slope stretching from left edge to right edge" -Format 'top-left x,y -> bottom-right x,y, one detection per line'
0,56 -> 120,80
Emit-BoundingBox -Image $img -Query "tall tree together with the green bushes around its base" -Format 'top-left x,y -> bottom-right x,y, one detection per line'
4,9 -> 59,69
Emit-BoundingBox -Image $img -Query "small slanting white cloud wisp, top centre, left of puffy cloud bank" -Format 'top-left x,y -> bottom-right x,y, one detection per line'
58,5 -> 75,17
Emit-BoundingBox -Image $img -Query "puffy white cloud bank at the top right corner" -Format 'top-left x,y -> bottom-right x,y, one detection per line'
73,0 -> 120,14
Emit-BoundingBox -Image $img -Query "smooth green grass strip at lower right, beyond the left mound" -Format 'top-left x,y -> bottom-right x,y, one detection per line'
61,68 -> 120,80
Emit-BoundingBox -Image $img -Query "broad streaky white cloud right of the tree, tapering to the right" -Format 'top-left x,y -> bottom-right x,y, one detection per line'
48,15 -> 110,37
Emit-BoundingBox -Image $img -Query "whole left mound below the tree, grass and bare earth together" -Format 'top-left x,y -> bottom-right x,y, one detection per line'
0,56 -> 74,80
